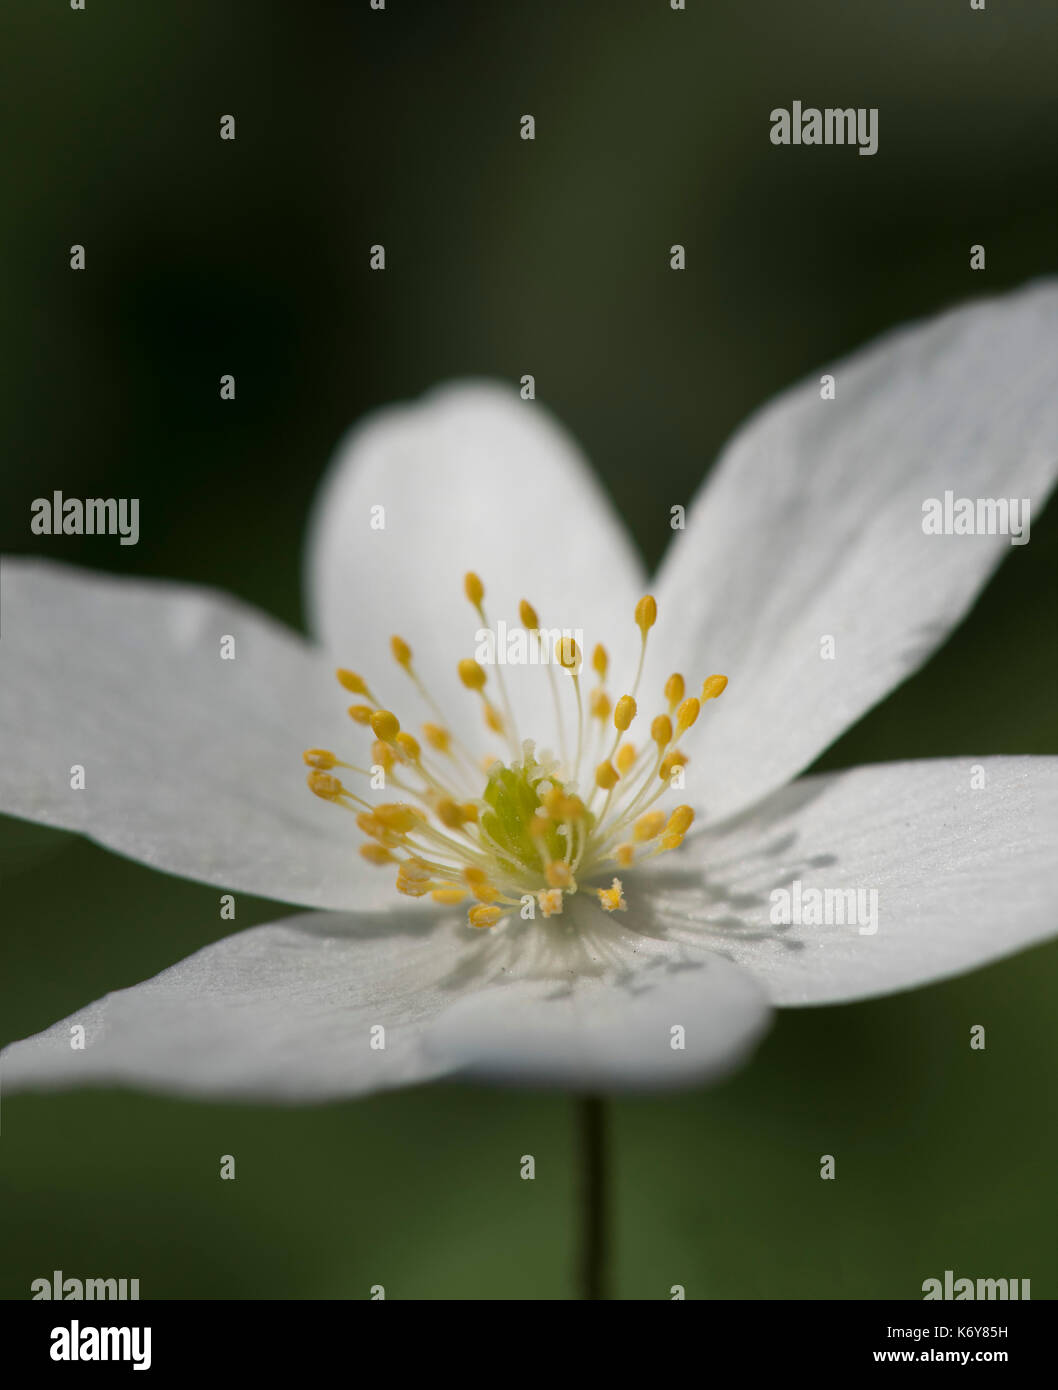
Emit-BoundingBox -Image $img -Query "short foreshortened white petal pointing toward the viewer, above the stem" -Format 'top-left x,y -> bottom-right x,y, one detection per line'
427,901 -> 770,1093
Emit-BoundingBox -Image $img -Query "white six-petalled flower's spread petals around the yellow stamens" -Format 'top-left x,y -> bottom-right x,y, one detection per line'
0,285 -> 1058,1101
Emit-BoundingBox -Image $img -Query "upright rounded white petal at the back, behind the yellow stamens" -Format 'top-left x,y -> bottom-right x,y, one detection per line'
307,382 -> 644,746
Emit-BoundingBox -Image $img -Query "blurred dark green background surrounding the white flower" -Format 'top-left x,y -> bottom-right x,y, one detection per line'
0,0 -> 1058,1298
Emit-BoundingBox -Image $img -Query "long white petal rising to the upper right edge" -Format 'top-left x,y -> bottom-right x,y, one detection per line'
645,282 -> 1058,820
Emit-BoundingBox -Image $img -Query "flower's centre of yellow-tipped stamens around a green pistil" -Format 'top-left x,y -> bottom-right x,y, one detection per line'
304,574 -> 727,927
